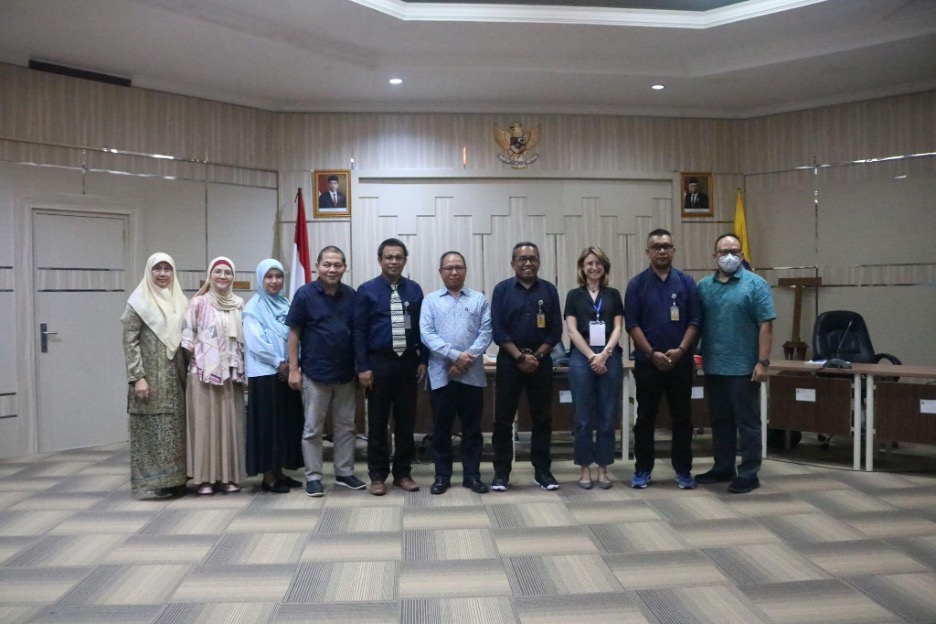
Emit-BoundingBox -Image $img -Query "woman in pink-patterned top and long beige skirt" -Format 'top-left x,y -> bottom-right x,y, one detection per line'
182,256 -> 247,495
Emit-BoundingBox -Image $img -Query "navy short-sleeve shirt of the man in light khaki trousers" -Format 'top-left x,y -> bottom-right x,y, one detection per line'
286,280 -> 354,384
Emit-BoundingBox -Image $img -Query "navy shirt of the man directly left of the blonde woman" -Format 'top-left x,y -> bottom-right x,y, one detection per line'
491,277 -> 562,349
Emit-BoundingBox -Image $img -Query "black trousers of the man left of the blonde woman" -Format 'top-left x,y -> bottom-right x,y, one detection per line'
492,351 -> 552,477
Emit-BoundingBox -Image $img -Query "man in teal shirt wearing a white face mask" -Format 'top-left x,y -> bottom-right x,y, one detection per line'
696,234 -> 777,494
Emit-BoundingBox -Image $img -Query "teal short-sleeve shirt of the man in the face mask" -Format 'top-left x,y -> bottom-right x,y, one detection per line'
699,268 -> 777,375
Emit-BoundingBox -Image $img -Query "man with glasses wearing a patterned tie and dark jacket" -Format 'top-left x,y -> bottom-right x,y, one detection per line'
354,238 -> 429,496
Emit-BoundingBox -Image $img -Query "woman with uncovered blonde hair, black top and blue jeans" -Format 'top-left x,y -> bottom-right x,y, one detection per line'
564,246 -> 624,490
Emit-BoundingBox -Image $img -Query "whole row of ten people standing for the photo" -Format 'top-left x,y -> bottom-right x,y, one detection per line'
121,230 -> 776,497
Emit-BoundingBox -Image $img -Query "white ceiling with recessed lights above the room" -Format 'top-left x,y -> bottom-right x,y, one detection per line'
0,0 -> 936,118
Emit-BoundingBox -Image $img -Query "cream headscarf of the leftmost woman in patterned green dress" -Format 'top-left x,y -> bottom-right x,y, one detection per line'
127,252 -> 188,360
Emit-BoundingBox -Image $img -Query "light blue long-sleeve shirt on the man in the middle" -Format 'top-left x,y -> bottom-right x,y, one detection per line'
419,288 -> 491,390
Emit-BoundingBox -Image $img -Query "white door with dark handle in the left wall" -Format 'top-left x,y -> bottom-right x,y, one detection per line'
32,209 -> 129,452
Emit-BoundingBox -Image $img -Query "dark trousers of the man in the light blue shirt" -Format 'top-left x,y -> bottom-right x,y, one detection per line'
429,381 -> 484,480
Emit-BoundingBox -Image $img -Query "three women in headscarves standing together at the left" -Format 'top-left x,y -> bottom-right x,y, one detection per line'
121,253 -> 302,498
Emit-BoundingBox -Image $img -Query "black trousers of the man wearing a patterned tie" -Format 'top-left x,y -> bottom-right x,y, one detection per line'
367,351 -> 419,481
